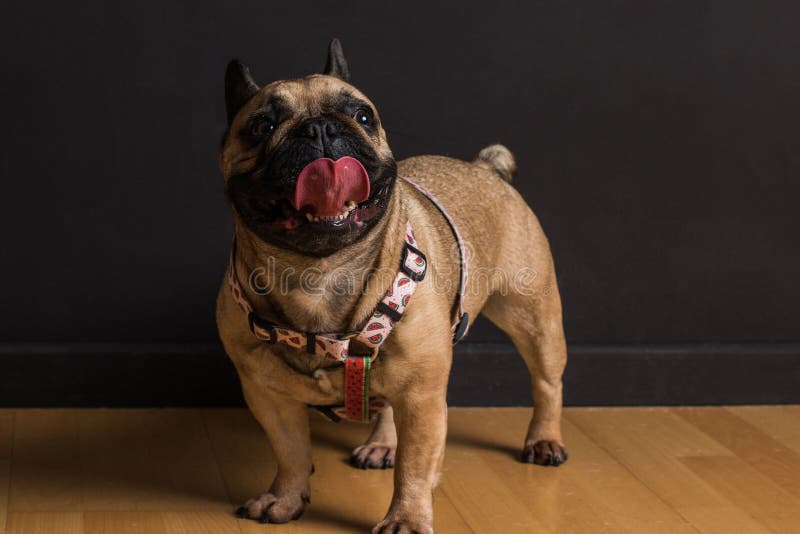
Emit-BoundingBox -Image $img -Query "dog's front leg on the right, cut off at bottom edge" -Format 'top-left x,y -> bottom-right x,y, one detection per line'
372,360 -> 449,534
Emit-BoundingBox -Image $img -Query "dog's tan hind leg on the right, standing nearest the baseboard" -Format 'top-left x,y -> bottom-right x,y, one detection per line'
483,269 -> 567,466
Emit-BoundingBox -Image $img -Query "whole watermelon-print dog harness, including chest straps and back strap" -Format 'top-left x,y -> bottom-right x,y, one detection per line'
226,177 -> 469,422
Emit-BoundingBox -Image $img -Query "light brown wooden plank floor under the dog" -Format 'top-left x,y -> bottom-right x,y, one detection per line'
0,406 -> 800,534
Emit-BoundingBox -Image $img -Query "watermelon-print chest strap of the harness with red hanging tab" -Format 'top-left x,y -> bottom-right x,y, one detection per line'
227,222 -> 428,422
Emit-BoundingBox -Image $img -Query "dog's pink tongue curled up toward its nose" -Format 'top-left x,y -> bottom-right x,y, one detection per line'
292,156 -> 369,217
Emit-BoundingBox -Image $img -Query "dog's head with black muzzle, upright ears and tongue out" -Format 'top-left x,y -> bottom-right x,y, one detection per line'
220,39 -> 396,256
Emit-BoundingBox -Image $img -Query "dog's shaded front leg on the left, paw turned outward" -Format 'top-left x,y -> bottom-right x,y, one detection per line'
236,375 -> 313,523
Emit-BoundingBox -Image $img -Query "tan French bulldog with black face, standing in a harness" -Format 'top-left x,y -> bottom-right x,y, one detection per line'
216,39 -> 567,533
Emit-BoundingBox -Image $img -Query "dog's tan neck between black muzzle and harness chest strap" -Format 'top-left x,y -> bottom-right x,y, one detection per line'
235,190 -> 405,333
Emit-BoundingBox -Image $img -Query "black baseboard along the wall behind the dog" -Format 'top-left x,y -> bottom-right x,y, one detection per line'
0,343 -> 800,407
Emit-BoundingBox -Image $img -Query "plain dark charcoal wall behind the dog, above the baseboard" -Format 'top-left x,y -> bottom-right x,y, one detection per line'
0,0 -> 800,406
